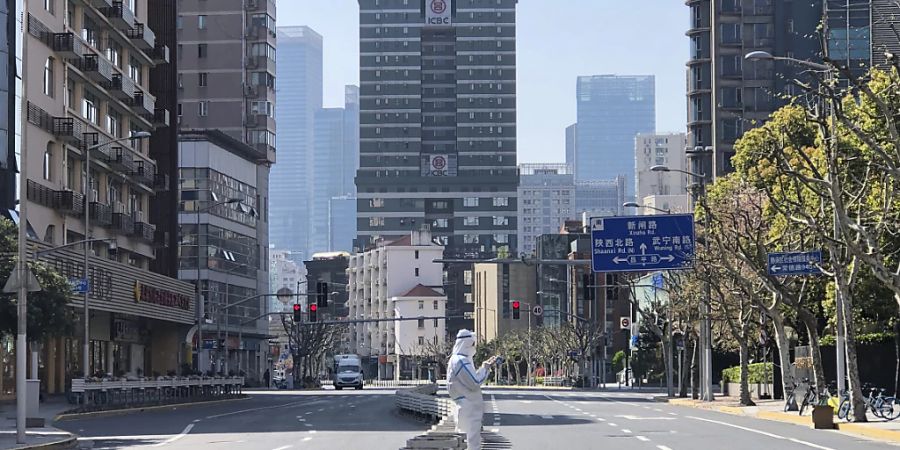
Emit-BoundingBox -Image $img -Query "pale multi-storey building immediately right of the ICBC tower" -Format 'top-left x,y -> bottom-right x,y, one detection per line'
517,164 -> 576,255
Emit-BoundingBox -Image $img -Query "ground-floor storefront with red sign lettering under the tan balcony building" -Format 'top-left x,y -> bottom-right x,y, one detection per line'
0,244 -> 195,399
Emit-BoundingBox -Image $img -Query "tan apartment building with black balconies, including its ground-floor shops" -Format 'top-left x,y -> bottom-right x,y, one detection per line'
15,0 -> 196,393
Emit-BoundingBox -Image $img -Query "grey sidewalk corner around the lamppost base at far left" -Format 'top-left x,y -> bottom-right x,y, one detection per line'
0,397 -> 76,450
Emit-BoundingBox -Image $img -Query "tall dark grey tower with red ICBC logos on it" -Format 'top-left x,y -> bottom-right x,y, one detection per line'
356,0 -> 518,331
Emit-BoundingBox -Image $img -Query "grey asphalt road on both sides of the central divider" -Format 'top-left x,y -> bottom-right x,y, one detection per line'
57,389 -> 900,450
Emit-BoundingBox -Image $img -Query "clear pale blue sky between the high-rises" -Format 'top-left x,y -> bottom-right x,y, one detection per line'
277,0 -> 689,162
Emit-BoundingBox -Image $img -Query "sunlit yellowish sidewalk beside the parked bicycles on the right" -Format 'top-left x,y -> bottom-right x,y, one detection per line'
655,396 -> 900,443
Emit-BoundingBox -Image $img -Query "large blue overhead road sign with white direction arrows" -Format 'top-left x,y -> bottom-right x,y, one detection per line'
591,214 -> 694,272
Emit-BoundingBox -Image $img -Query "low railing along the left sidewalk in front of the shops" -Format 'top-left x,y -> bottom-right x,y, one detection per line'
69,377 -> 244,410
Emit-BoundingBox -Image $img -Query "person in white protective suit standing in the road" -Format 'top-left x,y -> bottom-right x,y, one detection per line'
447,329 -> 497,450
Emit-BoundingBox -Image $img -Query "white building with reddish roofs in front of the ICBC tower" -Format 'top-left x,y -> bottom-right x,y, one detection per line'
348,231 -> 446,379
